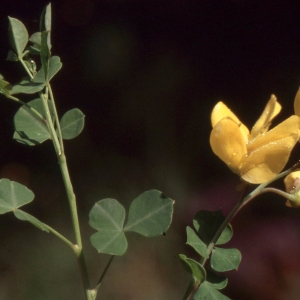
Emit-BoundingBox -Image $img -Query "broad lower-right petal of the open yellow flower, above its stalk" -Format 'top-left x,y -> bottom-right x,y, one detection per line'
241,116 -> 300,184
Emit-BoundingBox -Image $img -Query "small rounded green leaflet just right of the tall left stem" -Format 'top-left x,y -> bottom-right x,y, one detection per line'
60,108 -> 84,140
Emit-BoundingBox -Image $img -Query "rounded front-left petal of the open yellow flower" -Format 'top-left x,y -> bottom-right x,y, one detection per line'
210,118 -> 247,174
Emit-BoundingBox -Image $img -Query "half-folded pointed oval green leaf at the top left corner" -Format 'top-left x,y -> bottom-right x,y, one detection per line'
8,17 -> 28,58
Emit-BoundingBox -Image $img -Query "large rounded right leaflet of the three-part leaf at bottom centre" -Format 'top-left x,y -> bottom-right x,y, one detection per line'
124,190 -> 174,237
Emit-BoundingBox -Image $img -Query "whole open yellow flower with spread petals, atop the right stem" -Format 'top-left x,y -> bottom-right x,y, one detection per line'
210,95 -> 300,184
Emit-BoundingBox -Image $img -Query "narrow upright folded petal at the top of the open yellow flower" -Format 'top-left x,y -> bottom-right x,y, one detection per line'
249,95 -> 281,140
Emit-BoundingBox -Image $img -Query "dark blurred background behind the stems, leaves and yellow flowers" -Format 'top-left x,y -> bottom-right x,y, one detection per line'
0,0 -> 300,300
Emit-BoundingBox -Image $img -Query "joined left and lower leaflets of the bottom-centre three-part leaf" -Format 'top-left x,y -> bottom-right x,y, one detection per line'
89,198 -> 128,255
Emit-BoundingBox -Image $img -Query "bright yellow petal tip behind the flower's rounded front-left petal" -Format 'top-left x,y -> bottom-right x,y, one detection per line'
211,101 -> 249,143
